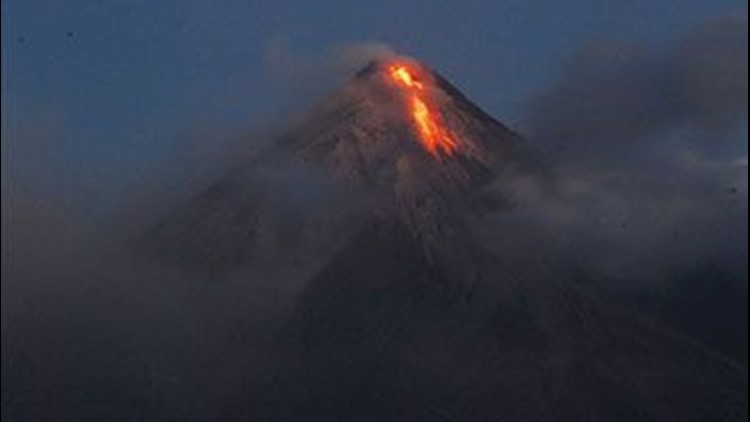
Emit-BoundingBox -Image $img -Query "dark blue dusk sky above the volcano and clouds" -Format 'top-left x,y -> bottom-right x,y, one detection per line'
2,0 -> 746,211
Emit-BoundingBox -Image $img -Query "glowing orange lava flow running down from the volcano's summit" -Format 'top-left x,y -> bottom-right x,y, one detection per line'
390,64 -> 458,157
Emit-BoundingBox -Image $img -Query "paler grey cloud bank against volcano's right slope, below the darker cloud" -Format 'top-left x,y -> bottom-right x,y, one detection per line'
485,155 -> 748,289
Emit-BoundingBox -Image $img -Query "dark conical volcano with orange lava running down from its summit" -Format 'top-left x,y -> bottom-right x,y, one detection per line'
140,58 -> 747,421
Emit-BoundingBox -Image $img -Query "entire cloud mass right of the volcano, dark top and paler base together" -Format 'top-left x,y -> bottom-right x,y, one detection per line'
490,9 -> 748,291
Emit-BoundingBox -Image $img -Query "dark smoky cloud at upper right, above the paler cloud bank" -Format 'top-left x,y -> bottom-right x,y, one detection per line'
528,13 -> 748,164
